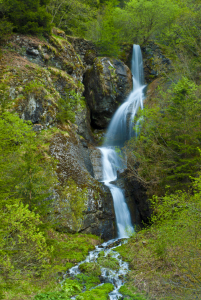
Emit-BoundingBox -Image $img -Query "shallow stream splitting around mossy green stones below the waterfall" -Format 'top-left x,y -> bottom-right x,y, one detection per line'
63,239 -> 129,300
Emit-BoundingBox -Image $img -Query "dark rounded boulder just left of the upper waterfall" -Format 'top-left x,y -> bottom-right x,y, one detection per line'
84,57 -> 132,129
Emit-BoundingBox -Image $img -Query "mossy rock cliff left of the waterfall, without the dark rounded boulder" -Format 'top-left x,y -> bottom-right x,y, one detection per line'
0,30 -> 115,239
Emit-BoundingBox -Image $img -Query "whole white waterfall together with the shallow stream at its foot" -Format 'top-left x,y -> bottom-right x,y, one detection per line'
66,45 -> 146,300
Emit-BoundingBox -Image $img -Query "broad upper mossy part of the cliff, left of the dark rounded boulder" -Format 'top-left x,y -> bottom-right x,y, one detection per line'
0,29 -> 94,142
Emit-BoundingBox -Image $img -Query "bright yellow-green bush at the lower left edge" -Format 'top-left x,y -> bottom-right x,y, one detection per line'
0,203 -> 51,278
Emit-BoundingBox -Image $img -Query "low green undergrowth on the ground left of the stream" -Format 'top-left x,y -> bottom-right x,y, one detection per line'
0,229 -> 100,300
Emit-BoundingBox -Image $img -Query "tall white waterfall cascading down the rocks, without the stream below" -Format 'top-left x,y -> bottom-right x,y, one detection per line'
99,45 -> 146,238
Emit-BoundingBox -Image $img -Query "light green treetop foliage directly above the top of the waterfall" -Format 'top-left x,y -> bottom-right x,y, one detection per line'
86,0 -> 180,56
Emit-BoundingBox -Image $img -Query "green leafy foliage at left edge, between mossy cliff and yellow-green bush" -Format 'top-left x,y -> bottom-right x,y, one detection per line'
0,112 -> 57,214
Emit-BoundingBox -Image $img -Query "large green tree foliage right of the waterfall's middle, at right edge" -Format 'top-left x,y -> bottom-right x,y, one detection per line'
125,77 -> 201,195
